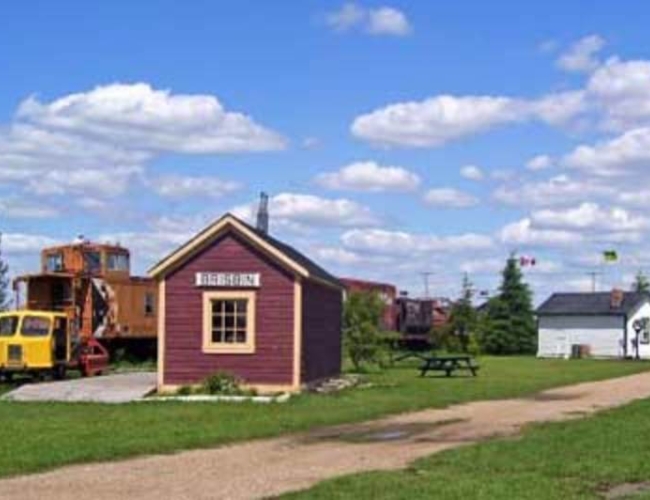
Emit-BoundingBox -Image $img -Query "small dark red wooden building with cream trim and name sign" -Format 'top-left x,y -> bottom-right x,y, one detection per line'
150,214 -> 343,392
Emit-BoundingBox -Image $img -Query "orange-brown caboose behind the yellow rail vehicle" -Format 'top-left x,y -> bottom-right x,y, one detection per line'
15,239 -> 157,347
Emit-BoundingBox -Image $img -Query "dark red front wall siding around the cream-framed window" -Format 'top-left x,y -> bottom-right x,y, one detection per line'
164,233 -> 294,385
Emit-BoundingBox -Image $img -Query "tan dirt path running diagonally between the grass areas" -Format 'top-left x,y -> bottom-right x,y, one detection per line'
0,373 -> 650,500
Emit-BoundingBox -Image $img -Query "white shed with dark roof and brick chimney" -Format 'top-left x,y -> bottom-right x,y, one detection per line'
537,290 -> 650,359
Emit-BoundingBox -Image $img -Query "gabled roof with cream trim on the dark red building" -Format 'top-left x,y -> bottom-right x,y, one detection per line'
148,213 -> 343,288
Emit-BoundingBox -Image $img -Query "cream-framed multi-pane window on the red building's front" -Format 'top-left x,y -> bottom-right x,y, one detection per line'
203,290 -> 256,354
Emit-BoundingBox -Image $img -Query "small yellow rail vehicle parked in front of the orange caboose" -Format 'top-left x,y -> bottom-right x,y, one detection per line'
0,311 -> 108,379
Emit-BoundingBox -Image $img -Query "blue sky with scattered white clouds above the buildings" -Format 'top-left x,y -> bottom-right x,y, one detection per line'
0,1 -> 650,300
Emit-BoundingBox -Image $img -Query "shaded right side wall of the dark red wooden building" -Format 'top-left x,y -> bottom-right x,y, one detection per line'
301,281 -> 343,383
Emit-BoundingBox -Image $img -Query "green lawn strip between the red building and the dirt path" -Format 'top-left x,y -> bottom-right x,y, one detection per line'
0,357 -> 650,476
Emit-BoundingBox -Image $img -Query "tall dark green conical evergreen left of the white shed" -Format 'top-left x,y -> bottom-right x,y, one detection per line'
482,254 -> 537,354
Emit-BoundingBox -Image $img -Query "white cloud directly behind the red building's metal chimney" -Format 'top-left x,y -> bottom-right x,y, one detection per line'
232,193 -> 379,231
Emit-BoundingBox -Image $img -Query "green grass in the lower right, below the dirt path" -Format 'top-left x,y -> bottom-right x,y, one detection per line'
282,384 -> 650,500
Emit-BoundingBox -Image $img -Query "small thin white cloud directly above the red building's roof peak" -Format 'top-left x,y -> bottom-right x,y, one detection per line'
149,174 -> 241,199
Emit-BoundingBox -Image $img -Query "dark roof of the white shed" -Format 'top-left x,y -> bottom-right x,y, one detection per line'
537,292 -> 650,316
